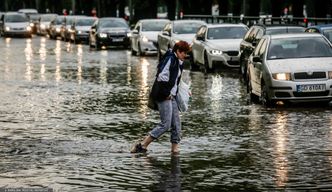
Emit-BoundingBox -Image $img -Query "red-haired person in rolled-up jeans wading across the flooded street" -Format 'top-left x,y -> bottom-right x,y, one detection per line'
130,41 -> 190,153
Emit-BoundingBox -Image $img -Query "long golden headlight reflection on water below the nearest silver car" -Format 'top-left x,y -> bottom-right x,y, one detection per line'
274,112 -> 288,187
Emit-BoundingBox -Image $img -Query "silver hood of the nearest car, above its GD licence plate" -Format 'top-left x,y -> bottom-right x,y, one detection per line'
267,57 -> 332,73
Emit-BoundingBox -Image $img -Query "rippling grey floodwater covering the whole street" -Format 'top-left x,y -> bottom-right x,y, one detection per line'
0,36 -> 332,191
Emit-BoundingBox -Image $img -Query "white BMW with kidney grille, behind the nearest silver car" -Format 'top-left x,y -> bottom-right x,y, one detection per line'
191,24 -> 248,71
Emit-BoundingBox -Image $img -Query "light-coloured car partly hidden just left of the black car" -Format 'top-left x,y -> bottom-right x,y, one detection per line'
69,17 -> 97,43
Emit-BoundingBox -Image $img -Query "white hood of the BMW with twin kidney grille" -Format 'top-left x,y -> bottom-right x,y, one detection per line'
206,39 -> 242,51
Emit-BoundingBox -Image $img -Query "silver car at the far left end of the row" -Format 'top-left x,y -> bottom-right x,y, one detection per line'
0,12 -> 31,37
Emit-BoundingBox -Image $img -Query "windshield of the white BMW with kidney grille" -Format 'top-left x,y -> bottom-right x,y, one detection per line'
207,27 -> 247,39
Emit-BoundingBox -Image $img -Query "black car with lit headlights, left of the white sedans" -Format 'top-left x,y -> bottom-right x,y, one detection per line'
89,17 -> 131,49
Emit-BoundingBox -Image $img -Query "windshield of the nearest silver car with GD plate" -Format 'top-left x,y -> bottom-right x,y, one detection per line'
267,37 -> 332,60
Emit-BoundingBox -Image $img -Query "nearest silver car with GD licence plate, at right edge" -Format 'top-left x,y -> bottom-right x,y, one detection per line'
248,33 -> 332,106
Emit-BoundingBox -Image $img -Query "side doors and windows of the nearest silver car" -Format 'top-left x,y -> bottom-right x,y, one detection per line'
248,38 -> 267,96
